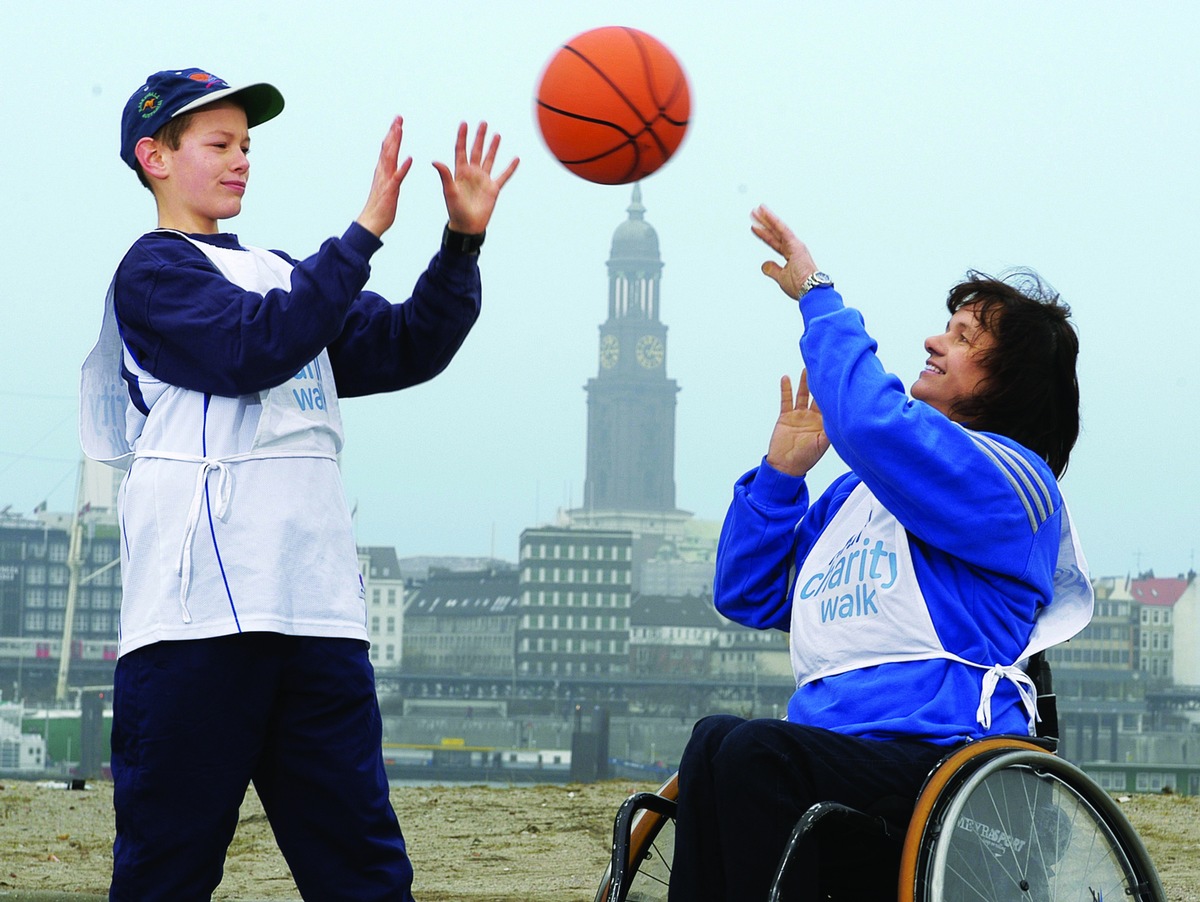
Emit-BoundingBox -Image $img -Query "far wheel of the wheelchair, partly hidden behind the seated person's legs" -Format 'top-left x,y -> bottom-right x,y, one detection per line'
595,774 -> 679,902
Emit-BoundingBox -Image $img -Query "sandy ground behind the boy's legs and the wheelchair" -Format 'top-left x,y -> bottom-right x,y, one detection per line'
0,781 -> 1200,902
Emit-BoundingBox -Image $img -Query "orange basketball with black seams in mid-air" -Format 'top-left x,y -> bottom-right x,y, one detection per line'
538,25 -> 691,185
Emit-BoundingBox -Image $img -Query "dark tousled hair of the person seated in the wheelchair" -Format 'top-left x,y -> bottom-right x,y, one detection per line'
946,270 -> 1079,476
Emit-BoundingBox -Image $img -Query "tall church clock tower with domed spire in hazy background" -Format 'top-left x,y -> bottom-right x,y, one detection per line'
583,185 -> 686,525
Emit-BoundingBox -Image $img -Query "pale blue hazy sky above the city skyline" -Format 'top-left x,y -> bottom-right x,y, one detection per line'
0,0 -> 1200,576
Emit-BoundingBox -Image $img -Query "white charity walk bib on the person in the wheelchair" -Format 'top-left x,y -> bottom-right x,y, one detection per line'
791,483 -> 1093,735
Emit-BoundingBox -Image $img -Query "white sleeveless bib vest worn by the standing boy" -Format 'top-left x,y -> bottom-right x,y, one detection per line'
79,236 -> 367,655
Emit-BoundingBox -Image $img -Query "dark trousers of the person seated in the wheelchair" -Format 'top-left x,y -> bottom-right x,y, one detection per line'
668,715 -> 947,902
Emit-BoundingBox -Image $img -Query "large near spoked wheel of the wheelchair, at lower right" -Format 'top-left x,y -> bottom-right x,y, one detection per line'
900,750 -> 1165,902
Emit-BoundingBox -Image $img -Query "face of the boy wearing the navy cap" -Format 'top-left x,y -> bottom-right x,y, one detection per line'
156,102 -> 250,234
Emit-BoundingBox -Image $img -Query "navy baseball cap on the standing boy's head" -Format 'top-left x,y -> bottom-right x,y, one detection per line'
121,68 -> 283,170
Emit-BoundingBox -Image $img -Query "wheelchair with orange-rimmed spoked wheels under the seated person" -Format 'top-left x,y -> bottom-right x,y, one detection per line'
595,662 -> 1166,902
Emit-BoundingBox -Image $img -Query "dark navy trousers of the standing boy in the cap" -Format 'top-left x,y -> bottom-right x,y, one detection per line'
109,633 -> 413,902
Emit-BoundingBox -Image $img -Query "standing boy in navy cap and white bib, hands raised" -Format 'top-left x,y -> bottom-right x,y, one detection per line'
80,68 -> 518,902
